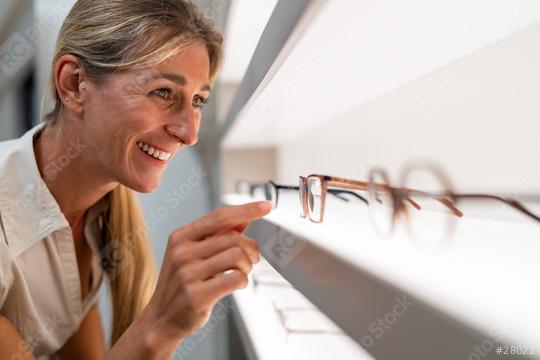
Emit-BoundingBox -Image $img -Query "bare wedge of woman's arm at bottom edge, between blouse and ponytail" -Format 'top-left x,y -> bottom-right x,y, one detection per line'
58,305 -> 106,360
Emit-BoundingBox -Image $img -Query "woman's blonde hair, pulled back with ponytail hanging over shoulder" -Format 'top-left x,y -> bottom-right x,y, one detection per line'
44,0 -> 223,345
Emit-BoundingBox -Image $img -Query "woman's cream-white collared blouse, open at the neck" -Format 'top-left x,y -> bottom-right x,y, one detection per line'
0,123 -> 105,359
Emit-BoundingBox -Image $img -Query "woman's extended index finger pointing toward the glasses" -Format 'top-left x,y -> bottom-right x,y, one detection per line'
180,201 -> 272,240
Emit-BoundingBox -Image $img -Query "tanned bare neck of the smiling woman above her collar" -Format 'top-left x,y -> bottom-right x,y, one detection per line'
34,119 -> 118,228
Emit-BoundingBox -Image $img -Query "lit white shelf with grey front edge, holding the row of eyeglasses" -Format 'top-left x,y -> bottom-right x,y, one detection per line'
223,194 -> 540,359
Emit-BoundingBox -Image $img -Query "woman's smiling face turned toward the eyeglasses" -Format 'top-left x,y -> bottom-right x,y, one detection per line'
82,43 -> 210,192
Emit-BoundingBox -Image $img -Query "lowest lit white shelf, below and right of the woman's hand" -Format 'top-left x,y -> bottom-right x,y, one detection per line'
228,258 -> 372,360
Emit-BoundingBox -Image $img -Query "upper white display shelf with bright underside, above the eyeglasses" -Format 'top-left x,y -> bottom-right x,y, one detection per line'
222,0 -> 540,148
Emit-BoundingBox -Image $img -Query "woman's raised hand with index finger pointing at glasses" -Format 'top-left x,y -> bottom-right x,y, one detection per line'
144,201 -> 271,345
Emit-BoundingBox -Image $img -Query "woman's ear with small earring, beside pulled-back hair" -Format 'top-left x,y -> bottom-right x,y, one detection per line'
54,54 -> 88,114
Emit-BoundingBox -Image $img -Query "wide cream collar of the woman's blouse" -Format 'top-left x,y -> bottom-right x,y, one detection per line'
0,123 -> 106,257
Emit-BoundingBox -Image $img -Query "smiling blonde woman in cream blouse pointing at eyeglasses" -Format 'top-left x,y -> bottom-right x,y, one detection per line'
0,0 -> 270,359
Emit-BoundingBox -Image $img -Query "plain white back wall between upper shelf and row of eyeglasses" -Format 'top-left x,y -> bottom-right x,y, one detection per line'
278,19 -> 540,192
